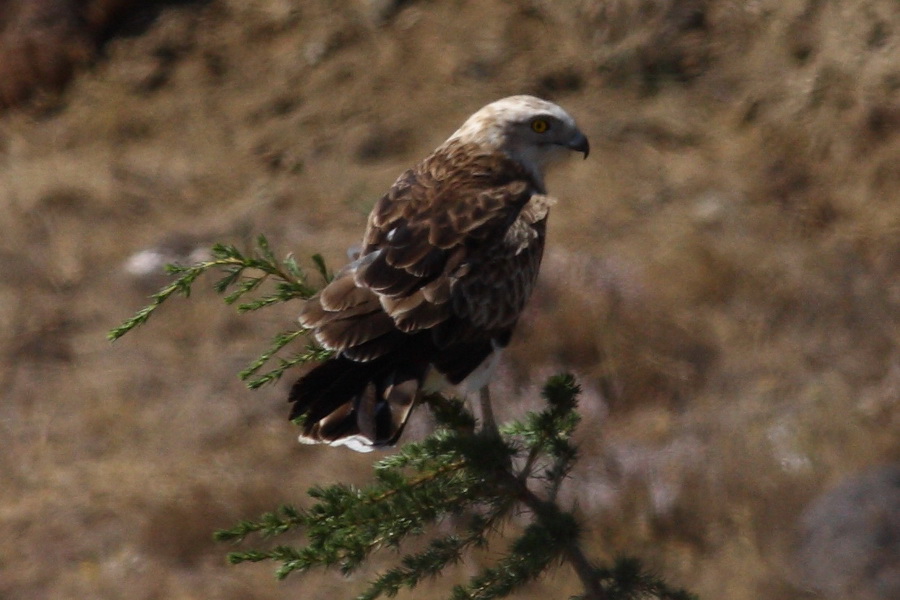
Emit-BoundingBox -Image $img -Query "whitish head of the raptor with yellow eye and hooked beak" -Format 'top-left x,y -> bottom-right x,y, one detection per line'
447,96 -> 590,179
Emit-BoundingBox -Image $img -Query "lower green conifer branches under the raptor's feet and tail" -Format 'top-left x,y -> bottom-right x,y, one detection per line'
217,375 -> 689,600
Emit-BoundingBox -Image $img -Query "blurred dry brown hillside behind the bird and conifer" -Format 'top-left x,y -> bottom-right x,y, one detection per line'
0,0 -> 900,600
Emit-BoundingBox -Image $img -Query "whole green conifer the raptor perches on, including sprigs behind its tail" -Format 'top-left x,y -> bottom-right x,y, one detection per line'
109,236 -> 691,600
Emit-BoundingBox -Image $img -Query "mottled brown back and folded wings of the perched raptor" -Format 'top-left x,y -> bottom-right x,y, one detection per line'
300,141 -> 547,368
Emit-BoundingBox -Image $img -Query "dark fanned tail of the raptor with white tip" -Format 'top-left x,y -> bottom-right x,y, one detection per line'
288,356 -> 427,452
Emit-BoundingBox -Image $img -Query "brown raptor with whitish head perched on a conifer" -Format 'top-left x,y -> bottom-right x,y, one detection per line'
289,96 -> 589,451
